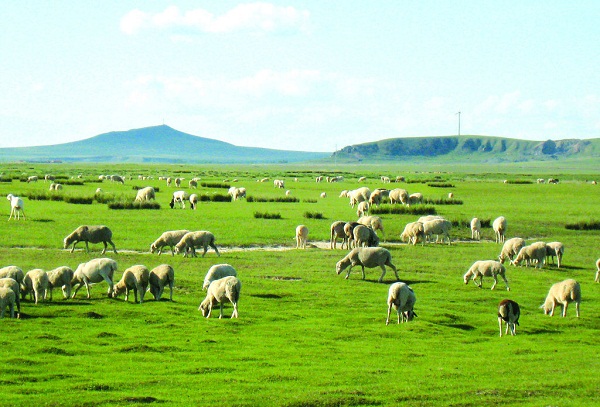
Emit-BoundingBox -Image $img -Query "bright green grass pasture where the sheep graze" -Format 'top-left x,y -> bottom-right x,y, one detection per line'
0,163 -> 600,407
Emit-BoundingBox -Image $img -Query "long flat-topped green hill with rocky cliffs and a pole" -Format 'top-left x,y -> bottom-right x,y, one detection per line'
334,136 -> 600,163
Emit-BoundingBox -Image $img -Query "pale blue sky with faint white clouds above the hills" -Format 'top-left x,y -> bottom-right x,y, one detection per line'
0,0 -> 600,152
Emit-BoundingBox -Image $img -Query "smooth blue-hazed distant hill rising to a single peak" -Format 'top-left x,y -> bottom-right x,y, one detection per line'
0,125 -> 331,163
